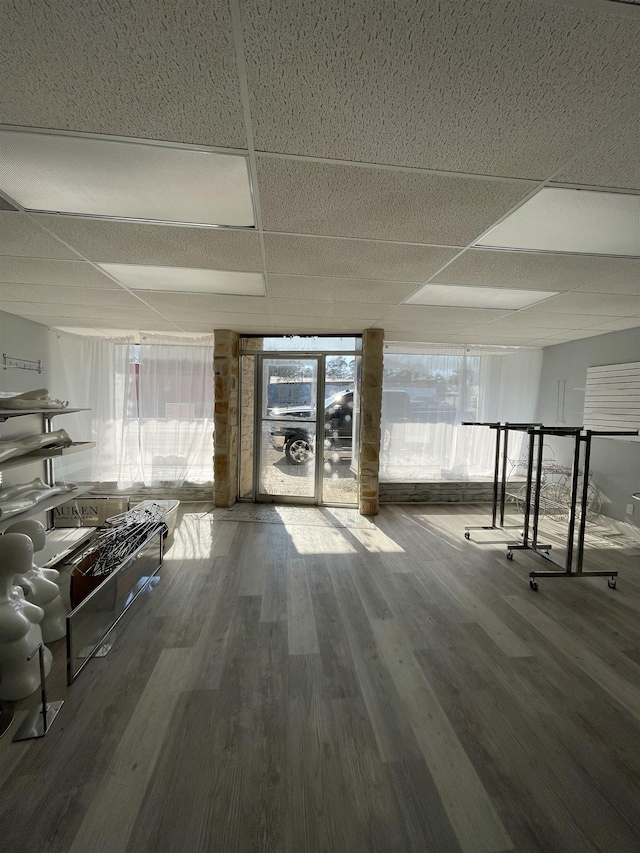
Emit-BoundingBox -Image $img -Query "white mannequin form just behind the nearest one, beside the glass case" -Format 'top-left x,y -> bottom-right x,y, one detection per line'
5,518 -> 67,643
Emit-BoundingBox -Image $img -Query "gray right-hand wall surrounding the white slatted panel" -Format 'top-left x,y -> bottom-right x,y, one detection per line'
536,328 -> 640,527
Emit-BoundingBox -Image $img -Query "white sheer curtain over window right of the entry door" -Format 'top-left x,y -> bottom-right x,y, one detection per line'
380,344 -> 542,482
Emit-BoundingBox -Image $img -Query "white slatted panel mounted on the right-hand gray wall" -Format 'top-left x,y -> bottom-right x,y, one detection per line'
584,361 -> 640,440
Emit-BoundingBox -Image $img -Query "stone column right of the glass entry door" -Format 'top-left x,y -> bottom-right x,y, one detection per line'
359,329 -> 384,515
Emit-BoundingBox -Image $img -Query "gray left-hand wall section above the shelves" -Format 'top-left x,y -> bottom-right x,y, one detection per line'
0,311 -> 50,394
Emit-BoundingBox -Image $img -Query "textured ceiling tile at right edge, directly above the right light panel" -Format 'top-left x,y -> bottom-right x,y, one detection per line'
554,110 -> 640,189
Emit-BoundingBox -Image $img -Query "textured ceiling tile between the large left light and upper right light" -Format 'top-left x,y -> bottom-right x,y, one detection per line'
258,157 -> 531,246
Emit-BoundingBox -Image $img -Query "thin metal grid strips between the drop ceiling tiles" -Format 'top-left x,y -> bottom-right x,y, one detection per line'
0,0 -> 640,344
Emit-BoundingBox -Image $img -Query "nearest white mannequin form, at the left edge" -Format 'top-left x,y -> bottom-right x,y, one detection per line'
0,533 -> 52,701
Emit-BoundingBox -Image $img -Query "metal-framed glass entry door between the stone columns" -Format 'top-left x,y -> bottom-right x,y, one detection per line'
256,355 -> 324,503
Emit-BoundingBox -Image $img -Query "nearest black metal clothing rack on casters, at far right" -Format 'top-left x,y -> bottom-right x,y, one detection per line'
507,425 -> 640,590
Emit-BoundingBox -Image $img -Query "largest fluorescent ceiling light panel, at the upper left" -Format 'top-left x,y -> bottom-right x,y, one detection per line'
0,130 -> 255,228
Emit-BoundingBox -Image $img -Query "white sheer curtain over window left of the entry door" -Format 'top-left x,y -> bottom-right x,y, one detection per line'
50,332 -> 213,489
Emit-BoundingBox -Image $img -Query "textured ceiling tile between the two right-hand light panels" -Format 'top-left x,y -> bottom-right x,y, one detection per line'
434,249 -> 637,291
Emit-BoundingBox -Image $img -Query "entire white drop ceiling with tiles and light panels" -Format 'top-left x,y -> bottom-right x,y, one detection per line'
0,0 -> 640,346
